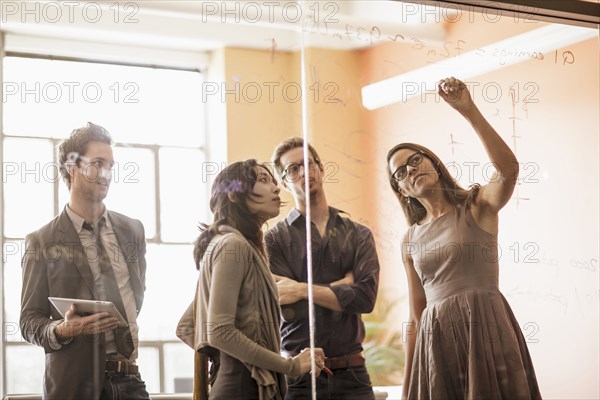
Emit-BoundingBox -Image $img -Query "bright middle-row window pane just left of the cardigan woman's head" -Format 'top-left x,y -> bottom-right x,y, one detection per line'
159,148 -> 207,242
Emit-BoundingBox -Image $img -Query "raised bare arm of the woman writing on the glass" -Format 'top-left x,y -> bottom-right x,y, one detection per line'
438,77 -> 519,216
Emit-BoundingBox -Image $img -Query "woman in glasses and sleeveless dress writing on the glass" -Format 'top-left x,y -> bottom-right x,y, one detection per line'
387,78 -> 541,400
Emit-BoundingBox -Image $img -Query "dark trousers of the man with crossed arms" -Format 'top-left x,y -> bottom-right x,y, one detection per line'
285,366 -> 375,400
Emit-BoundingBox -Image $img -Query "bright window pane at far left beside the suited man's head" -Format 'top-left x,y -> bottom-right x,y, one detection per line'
3,138 -> 54,238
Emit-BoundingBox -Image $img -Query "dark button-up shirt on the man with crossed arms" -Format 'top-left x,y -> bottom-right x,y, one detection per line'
265,207 -> 379,357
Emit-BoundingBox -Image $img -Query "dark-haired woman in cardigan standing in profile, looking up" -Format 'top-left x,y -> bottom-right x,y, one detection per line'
177,160 -> 324,400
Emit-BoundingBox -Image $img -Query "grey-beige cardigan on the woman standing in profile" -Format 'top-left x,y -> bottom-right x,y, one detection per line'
177,226 -> 300,400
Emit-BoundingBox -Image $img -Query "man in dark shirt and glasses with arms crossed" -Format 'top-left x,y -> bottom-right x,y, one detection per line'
265,138 -> 379,400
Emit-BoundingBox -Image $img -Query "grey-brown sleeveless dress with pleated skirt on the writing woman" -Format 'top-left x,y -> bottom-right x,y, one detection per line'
406,206 -> 541,400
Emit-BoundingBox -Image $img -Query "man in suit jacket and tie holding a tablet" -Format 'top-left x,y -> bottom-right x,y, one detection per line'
20,123 -> 149,400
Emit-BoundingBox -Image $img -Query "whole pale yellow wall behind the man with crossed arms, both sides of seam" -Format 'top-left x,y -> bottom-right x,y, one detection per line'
225,48 -> 369,220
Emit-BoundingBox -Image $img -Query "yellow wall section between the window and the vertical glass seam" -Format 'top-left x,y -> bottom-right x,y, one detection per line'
225,48 -> 302,162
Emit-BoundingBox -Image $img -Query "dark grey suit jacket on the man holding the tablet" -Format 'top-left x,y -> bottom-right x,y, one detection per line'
20,210 -> 146,400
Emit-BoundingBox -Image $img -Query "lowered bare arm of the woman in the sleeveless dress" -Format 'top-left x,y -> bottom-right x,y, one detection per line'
402,233 -> 427,399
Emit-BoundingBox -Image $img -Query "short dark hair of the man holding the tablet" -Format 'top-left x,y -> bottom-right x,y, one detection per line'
58,122 -> 112,190
